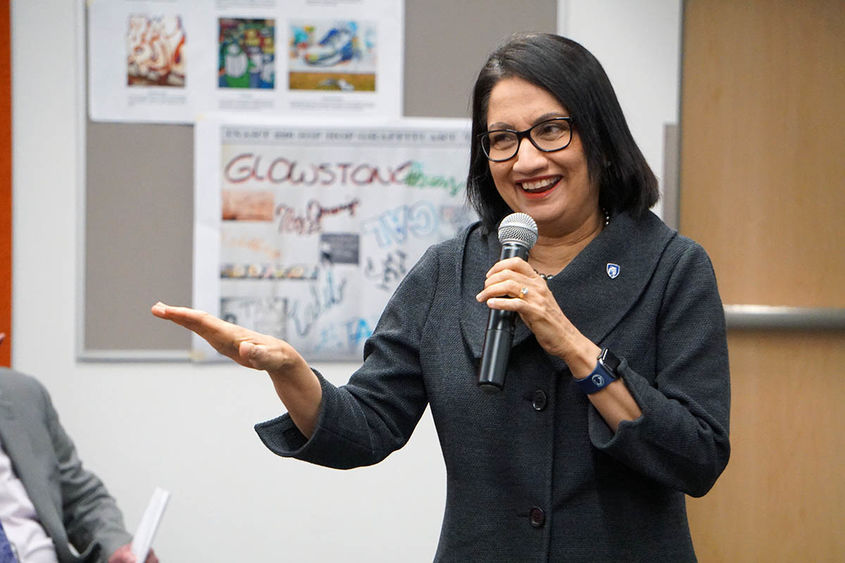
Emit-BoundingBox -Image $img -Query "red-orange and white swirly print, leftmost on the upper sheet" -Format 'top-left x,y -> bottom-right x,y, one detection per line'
126,14 -> 186,88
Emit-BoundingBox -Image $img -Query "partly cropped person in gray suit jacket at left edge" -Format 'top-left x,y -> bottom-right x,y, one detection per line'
0,368 -> 158,563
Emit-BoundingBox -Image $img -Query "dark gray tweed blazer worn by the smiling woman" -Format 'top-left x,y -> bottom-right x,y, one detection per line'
256,213 -> 730,562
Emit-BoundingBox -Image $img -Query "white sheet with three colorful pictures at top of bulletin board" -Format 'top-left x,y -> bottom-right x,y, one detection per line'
87,0 -> 404,123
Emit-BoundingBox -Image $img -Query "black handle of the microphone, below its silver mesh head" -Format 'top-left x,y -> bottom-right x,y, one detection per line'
478,242 -> 528,393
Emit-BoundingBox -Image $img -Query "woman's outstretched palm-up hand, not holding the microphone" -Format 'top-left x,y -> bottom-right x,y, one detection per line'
151,302 -> 299,374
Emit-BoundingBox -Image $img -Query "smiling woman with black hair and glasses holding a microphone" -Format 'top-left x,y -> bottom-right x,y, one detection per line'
152,33 -> 730,563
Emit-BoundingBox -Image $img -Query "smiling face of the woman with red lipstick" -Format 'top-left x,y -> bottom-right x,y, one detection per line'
487,78 -> 601,236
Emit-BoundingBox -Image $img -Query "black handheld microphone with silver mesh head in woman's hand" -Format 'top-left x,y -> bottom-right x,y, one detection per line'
478,213 -> 537,393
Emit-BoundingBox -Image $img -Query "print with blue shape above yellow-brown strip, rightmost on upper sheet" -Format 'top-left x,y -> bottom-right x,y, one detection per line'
288,21 -> 378,92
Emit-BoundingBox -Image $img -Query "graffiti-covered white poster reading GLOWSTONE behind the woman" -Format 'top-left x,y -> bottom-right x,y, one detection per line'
192,117 -> 475,361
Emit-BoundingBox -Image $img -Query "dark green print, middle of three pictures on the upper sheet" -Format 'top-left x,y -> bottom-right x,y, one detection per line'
217,18 -> 276,90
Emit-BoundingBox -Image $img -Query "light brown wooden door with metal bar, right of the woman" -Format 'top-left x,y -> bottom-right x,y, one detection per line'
680,0 -> 845,562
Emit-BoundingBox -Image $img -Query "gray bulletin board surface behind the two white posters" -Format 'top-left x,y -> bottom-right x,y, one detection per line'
79,0 -> 557,361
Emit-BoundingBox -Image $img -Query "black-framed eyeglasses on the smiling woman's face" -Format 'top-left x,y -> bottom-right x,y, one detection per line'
478,117 -> 572,162
